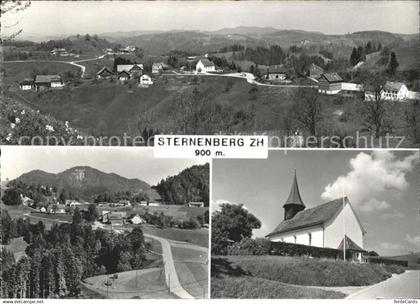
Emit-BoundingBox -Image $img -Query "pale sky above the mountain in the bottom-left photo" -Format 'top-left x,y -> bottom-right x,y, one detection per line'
1,146 -> 205,185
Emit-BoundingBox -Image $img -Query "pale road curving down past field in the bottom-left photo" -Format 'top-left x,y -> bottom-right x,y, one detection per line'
144,234 -> 194,299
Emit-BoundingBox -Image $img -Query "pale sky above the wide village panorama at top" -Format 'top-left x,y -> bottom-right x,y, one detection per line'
2,1 -> 419,36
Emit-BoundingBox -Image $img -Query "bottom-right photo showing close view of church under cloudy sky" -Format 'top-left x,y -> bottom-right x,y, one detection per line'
211,150 -> 420,299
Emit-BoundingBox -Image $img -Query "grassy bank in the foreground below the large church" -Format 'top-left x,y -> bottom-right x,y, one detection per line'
212,256 -> 403,298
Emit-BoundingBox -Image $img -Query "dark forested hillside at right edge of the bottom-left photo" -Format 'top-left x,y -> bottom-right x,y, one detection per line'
153,163 -> 209,207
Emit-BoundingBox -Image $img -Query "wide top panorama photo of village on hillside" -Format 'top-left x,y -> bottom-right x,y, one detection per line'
0,1 -> 420,148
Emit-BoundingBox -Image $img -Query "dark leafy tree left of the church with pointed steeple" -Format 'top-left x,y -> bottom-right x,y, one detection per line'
211,204 -> 261,254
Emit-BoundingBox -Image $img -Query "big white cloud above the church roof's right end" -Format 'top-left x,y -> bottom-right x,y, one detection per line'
321,150 -> 419,212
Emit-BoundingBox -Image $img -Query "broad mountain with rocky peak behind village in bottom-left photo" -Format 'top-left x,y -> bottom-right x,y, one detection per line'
16,166 -> 150,200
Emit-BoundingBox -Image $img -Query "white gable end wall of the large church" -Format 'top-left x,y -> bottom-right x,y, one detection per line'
324,204 -> 363,248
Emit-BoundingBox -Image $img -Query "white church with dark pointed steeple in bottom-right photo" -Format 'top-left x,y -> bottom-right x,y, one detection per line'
266,171 -> 366,261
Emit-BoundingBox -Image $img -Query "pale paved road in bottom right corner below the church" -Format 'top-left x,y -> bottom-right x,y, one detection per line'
347,270 -> 420,299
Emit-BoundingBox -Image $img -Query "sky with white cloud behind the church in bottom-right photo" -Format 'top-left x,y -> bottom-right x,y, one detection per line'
211,150 -> 420,256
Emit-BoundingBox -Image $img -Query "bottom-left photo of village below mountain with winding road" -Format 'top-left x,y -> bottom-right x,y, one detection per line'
0,146 -> 209,299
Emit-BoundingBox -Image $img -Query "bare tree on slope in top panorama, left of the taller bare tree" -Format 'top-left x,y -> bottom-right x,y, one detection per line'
292,89 -> 322,136
